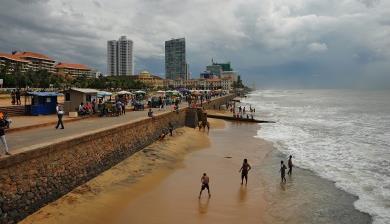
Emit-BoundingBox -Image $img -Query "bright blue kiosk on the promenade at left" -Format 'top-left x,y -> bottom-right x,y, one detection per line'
26,92 -> 62,115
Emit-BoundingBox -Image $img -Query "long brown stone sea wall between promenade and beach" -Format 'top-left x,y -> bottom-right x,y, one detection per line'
0,96 -> 232,224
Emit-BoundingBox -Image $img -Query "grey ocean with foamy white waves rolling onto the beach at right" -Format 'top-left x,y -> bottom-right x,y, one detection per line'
242,90 -> 390,224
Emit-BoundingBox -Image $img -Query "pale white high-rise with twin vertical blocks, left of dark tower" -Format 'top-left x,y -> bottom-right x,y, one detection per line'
107,36 -> 134,75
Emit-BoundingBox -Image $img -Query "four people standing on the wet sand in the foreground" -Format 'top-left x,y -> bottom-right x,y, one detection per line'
199,155 -> 293,198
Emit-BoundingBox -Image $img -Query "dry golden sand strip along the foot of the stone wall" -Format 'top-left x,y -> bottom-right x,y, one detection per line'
20,121 -> 219,223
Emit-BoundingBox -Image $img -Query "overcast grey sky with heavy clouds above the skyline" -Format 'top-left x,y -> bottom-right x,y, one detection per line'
0,0 -> 390,87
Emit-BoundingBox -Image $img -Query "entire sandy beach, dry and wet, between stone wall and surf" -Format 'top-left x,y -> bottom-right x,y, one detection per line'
22,120 -> 371,224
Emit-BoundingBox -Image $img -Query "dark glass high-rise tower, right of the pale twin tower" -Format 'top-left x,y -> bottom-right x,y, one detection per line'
165,38 -> 190,80
